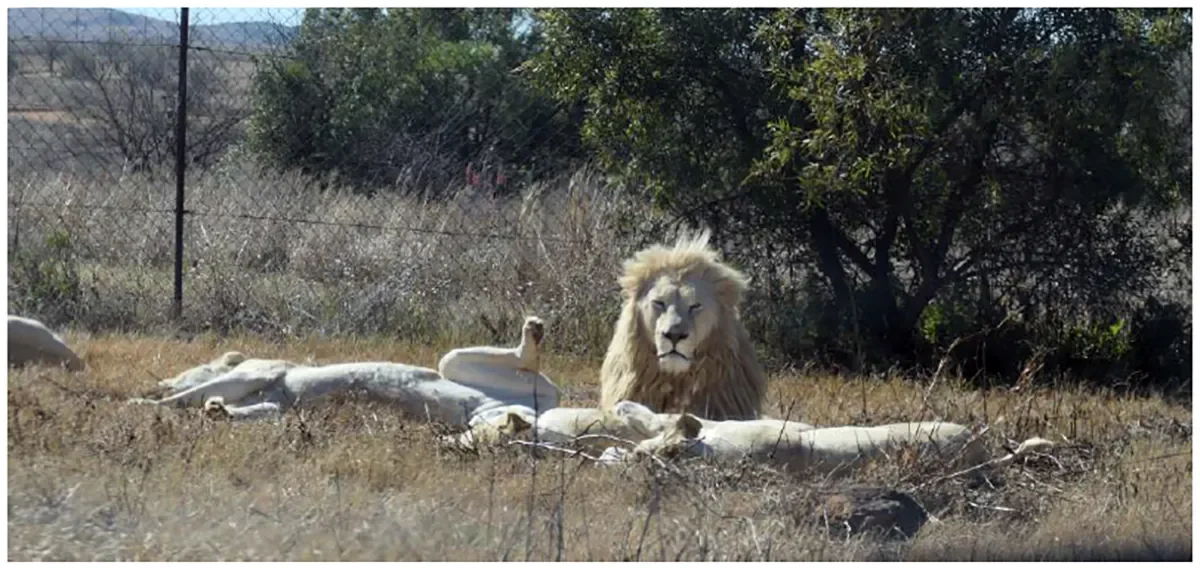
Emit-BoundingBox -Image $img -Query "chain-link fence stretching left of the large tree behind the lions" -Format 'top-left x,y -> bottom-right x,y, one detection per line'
8,8 -> 649,349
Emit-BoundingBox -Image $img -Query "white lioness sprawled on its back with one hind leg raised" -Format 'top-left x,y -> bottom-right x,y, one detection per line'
129,317 -> 558,425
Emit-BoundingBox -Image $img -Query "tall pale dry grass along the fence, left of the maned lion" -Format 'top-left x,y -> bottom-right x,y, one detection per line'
8,156 -> 655,352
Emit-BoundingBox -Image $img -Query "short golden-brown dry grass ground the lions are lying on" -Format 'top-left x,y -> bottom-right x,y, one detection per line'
7,329 -> 1192,561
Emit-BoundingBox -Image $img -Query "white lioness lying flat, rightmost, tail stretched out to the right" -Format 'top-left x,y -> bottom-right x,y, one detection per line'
604,414 -> 1052,474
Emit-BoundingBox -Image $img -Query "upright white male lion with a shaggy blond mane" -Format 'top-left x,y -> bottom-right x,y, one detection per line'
600,231 -> 767,419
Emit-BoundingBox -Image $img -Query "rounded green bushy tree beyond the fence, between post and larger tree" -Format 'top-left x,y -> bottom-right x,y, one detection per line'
250,8 -> 571,189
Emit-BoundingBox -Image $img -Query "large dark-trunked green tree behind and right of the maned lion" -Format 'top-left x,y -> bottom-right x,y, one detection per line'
529,10 -> 1190,355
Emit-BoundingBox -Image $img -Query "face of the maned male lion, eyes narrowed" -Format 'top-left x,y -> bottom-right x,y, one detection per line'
637,275 -> 720,375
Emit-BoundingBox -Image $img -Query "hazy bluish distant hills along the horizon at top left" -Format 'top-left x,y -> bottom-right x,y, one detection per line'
8,8 -> 298,48
